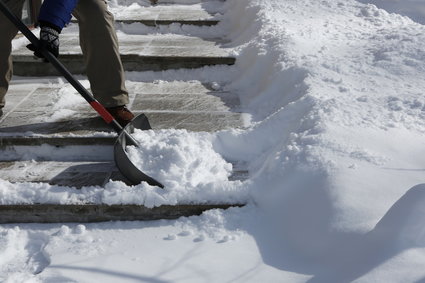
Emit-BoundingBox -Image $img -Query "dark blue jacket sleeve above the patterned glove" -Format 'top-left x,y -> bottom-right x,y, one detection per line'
38,0 -> 78,30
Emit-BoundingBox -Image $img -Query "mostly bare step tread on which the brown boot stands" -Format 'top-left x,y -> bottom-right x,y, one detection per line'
0,82 -> 244,136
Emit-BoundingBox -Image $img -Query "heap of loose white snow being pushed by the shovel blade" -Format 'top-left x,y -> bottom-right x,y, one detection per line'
128,130 -> 232,187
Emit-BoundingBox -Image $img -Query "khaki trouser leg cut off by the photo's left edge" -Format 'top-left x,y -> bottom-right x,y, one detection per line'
0,0 -> 24,109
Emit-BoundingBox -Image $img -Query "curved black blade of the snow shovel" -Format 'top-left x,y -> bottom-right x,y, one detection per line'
114,114 -> 164,188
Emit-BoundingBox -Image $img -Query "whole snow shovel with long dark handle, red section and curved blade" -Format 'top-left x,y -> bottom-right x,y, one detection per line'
0,0 -> 164,191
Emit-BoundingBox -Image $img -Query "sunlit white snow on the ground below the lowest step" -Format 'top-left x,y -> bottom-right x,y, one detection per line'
0,208 -> 310,283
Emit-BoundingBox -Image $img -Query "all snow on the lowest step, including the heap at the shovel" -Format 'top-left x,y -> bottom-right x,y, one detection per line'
0,130 -> 250,207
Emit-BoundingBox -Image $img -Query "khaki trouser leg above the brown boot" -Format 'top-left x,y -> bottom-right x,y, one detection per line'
73,0 -> 128,107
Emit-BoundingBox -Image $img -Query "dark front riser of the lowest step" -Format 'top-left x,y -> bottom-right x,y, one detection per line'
0,204 -> 244,224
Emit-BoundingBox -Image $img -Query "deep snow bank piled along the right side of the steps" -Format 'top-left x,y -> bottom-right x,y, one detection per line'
212,0 -> 425,266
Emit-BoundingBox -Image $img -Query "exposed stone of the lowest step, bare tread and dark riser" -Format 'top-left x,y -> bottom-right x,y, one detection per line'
0,156 -> 248,224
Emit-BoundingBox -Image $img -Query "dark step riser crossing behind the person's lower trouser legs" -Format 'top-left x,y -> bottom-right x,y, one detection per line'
13,55 -> 235,77
